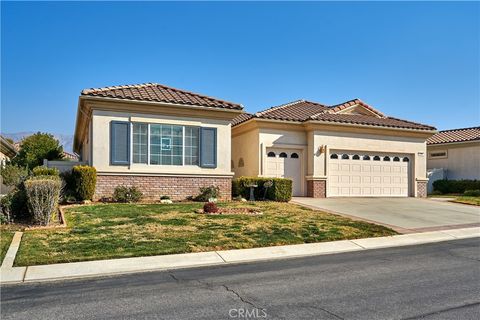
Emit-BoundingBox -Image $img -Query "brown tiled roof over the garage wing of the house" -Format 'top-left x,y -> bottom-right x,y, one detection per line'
232,99 -> 435,130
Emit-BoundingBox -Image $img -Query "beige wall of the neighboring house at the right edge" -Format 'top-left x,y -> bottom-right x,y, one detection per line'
427,142 -> 480,180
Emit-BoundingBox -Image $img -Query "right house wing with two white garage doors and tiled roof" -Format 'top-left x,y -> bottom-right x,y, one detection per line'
232,99 -> 436,198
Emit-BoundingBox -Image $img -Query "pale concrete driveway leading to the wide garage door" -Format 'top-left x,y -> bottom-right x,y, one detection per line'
292,198 -> 480,233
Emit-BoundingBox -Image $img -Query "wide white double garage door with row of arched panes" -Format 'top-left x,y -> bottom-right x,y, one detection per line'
327,150 -> 410,197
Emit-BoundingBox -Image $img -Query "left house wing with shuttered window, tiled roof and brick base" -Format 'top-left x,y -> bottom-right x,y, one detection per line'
74,83 -> 243,200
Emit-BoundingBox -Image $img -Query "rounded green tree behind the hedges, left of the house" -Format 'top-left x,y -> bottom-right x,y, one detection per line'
12,132 -> 63,169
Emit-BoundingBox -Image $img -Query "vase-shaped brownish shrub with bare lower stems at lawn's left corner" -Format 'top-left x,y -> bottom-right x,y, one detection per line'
25,176 -> 62,226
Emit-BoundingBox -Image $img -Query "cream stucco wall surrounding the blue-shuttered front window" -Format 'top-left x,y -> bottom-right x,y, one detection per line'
91,110 -> 233,176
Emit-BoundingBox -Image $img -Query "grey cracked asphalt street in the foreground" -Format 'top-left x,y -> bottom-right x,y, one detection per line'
1,238 -> 480,320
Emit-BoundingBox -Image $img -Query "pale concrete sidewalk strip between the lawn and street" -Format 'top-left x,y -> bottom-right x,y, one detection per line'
0,227 -> 480,284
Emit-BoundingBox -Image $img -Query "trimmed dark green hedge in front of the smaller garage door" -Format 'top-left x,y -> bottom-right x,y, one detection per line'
232,177 -> 292,202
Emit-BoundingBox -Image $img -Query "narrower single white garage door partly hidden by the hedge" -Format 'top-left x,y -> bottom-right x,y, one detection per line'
265,148 -> 302,196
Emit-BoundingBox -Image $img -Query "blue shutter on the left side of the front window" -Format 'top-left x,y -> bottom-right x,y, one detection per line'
110,121 -> 130,165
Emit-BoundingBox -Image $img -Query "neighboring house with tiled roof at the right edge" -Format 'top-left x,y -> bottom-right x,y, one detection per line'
427,127 -> 480,180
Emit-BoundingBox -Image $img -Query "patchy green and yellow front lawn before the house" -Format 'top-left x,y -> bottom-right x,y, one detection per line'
15,202 -> 396,266
